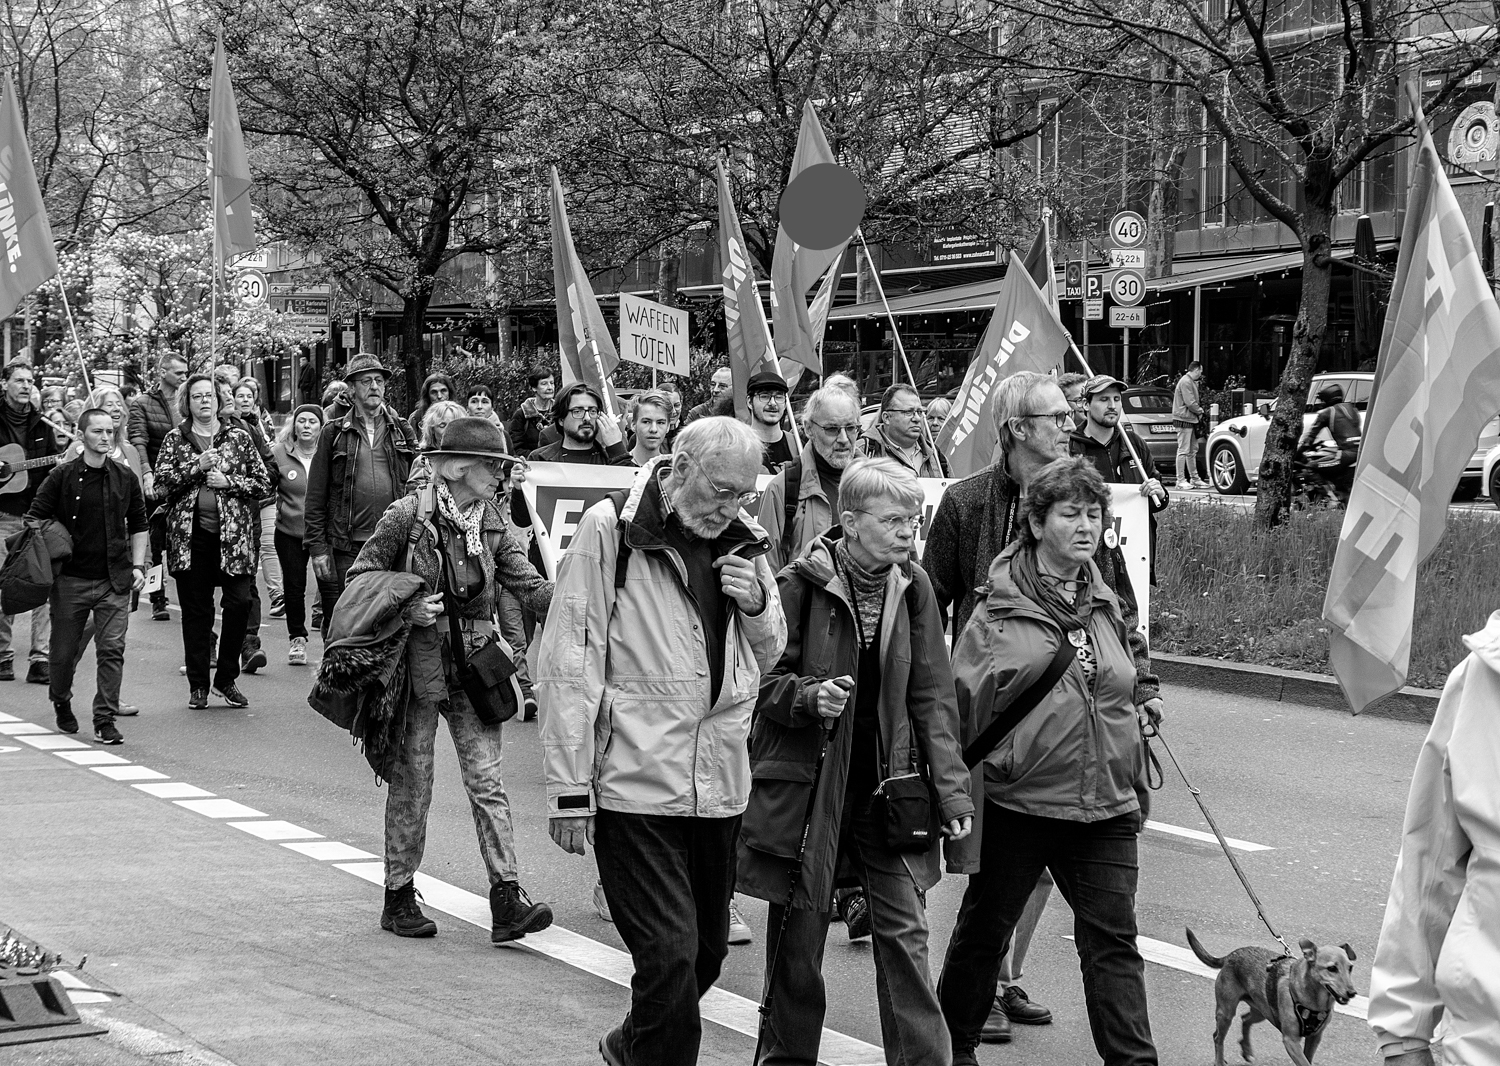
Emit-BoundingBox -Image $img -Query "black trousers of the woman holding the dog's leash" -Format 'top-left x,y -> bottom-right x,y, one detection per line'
938,802 -> 1157,1066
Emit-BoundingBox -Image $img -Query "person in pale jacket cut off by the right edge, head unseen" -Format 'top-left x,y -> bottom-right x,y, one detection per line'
1370,610 -> 1500,1066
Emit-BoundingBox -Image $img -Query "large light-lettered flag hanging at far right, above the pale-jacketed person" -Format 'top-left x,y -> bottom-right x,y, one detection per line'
1323,108 -> 1500,714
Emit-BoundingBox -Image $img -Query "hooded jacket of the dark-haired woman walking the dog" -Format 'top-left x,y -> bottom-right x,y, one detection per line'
948,541 -> 1145,874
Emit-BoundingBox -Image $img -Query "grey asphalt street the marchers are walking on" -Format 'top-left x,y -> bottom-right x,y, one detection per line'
0,590 -> 1424,1066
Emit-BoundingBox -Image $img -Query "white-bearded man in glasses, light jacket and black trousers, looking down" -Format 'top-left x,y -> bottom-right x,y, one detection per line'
536,418 -> 786,1066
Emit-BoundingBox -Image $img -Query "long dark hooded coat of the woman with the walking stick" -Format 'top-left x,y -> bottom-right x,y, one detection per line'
738,537 -> 974,910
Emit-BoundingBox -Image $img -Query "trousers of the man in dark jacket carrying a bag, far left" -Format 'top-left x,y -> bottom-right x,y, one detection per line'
48,574 -> 131,726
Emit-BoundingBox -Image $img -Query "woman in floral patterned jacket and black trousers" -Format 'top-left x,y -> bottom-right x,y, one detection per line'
156,373 -> 272,708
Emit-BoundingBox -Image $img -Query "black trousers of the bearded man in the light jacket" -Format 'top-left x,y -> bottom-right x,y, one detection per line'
594,810 -> 740,1066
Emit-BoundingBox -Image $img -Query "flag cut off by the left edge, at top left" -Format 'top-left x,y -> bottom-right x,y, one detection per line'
0,78 -> 57,318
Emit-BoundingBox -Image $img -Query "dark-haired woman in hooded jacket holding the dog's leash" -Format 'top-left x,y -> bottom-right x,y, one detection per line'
938,459 -> 1157,1066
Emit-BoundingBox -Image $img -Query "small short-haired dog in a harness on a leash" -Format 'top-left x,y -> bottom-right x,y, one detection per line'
1188,930 -> 1355,1066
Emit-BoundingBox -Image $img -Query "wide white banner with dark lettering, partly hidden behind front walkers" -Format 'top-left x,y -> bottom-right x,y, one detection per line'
521,463 -> 1151,634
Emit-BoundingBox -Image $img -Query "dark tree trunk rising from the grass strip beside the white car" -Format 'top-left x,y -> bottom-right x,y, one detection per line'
1256,204 -> 1334,529
